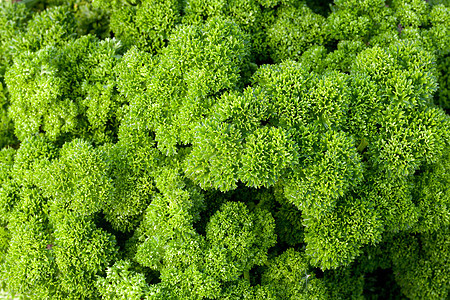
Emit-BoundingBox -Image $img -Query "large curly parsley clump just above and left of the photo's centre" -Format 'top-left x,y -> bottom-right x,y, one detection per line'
118,19 -> 249,155
